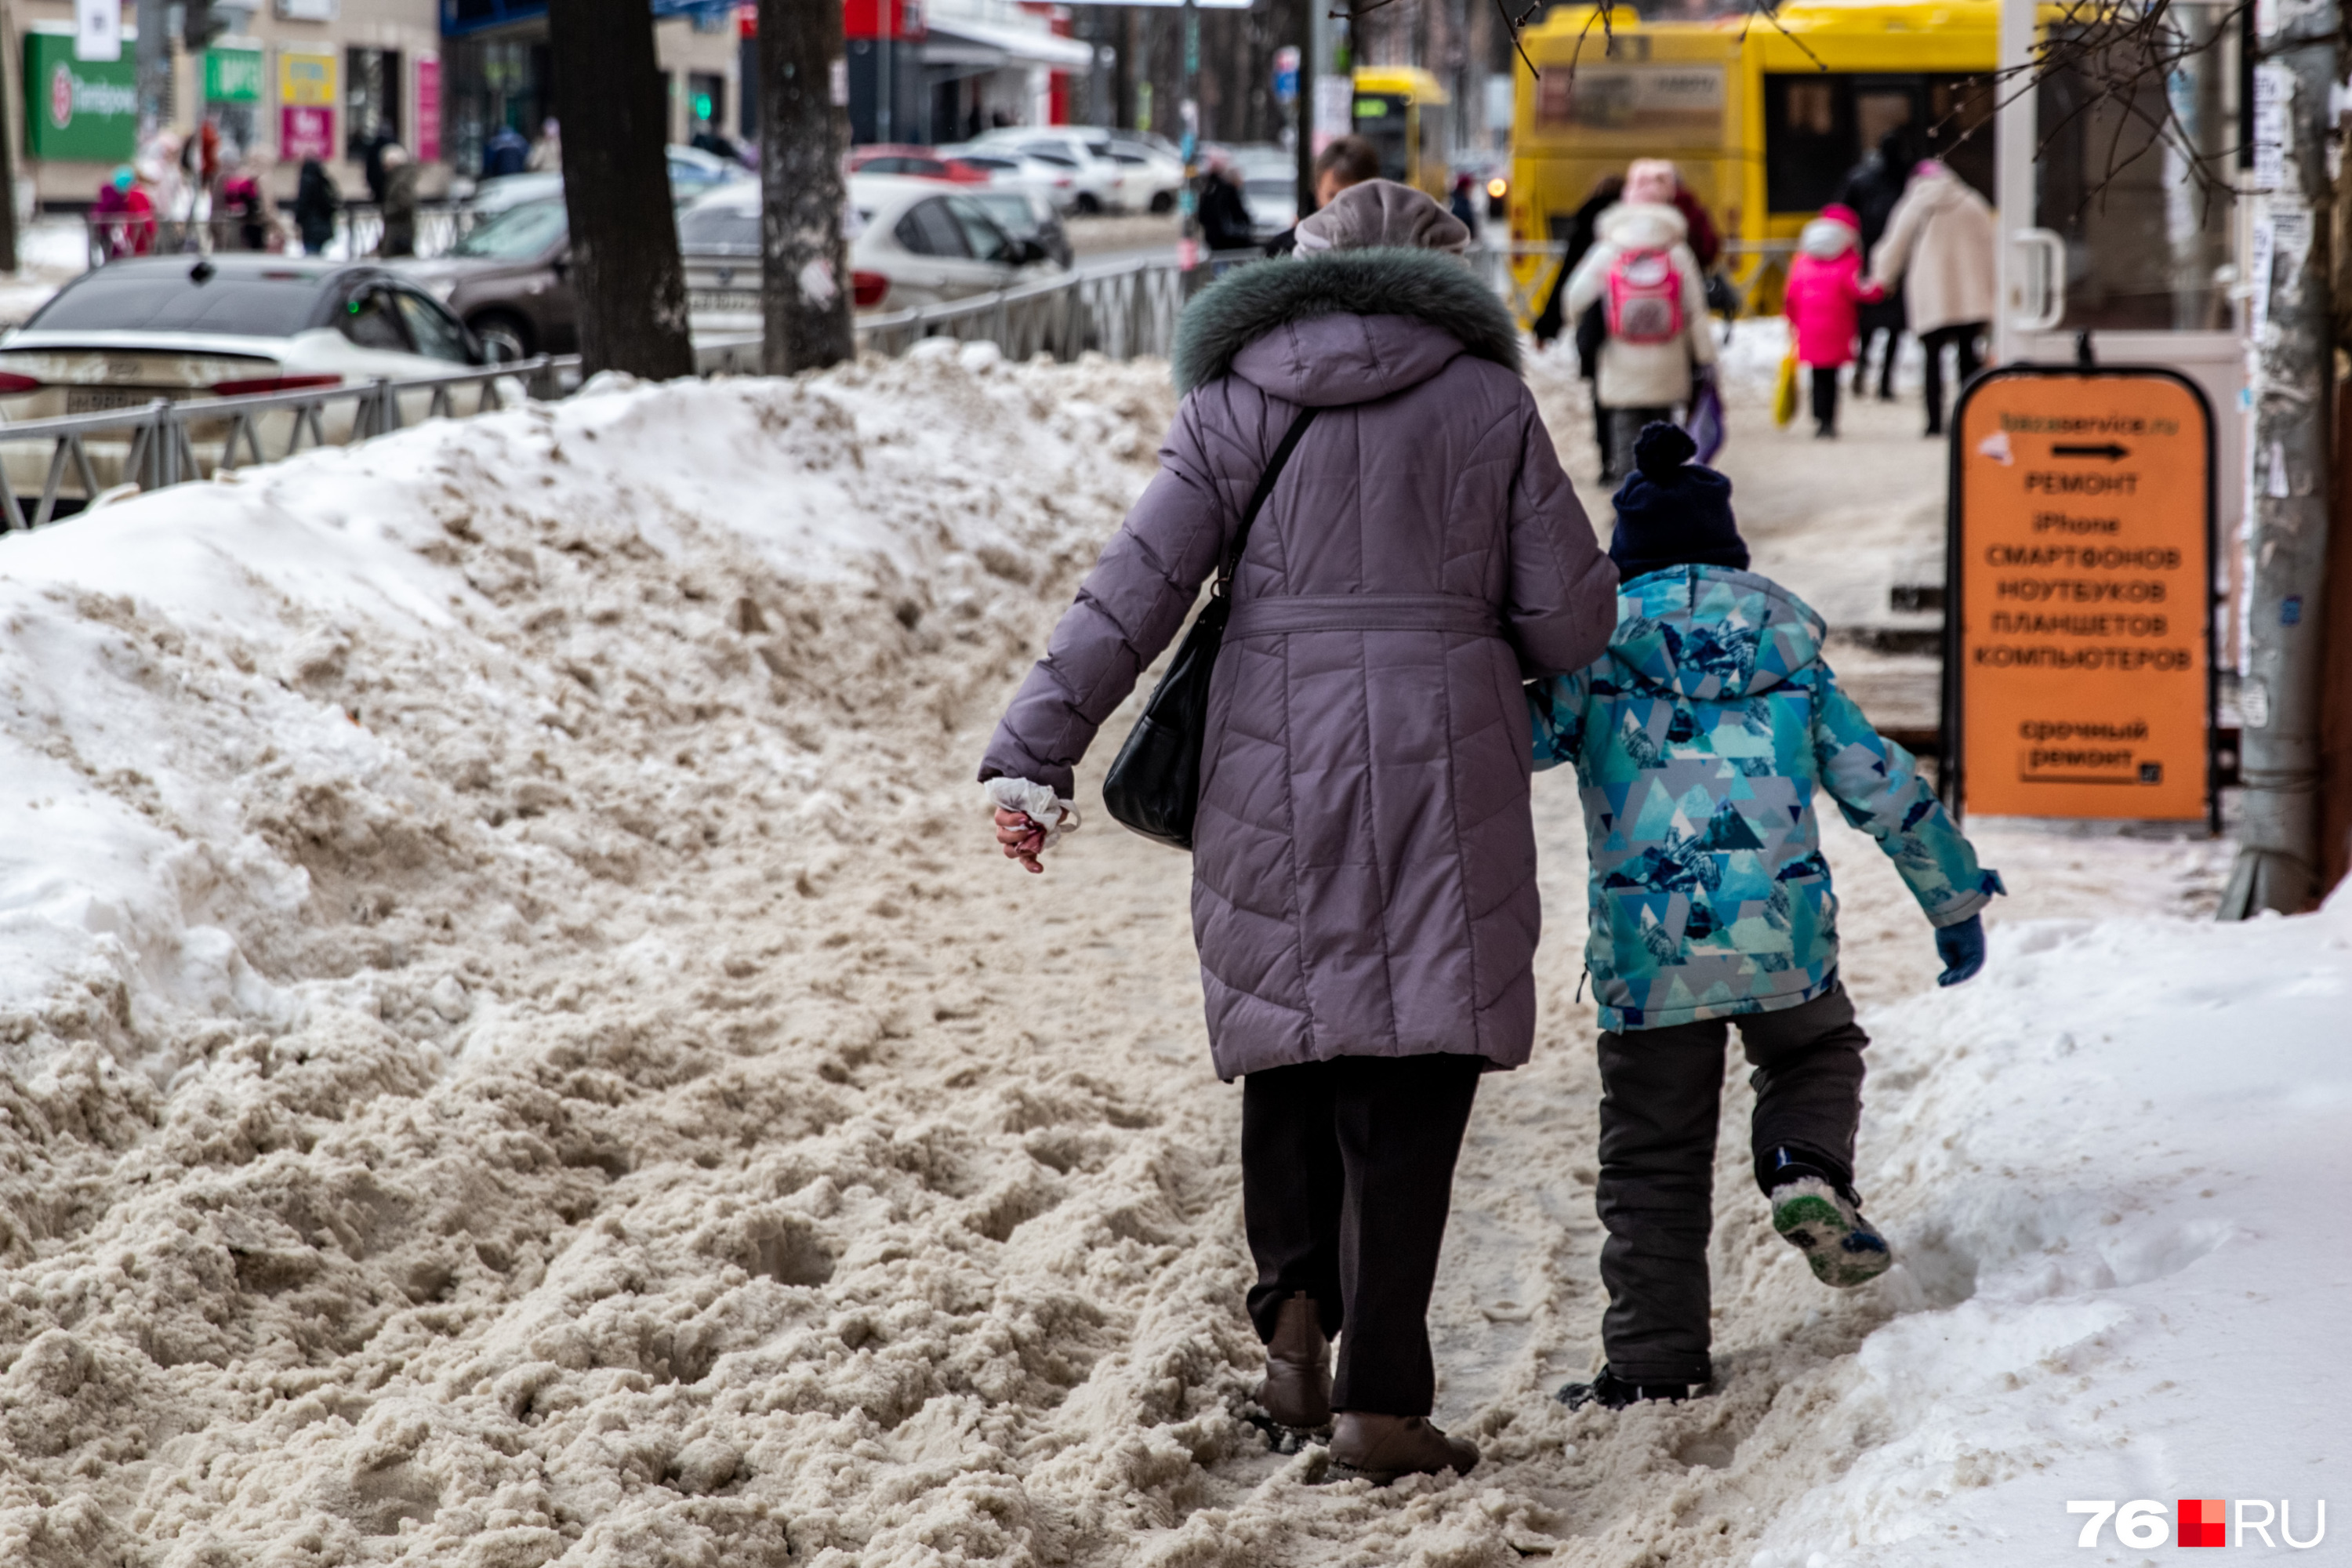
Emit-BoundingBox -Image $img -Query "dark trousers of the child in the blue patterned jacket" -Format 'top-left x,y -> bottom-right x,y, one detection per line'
1595,987 -> 1870,1382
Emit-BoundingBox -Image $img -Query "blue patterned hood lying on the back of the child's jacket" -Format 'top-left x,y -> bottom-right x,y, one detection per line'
1609,567 -> 1828,703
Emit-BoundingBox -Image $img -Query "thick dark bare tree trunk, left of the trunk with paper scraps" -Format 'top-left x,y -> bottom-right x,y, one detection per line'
548,0 -> 694,381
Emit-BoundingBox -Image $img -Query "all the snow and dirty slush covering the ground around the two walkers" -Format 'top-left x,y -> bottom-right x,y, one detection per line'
0,348 -> 2324,1568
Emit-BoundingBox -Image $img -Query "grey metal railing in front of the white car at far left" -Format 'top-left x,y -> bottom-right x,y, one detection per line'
0,355 -> 579,529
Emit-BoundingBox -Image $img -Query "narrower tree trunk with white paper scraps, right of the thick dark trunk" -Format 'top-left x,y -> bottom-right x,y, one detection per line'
760,0 -> 851,376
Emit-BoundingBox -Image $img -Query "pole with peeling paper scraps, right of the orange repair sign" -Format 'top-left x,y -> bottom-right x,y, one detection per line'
2220,0 -> 2340,919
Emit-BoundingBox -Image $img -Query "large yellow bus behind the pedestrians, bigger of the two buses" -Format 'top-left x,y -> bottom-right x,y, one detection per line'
1510,0 -> 1999,310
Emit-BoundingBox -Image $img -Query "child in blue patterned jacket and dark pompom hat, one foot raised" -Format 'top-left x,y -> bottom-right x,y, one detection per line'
1526,423 -> 2006,1408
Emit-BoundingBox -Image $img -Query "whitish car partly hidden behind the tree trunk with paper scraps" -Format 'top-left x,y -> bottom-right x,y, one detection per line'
677,174 -> 1061,334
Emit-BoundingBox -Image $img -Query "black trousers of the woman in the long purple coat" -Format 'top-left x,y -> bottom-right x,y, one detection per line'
1242,1055 -> 1486,1415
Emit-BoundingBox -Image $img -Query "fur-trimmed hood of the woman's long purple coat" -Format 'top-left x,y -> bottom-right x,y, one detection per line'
1174,249 -> 1519,407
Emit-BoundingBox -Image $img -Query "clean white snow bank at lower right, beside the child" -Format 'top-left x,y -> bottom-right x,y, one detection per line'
1755,895 -> 2352,1568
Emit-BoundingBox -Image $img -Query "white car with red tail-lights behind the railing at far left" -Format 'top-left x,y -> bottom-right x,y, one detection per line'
0,252 -> 503,510
